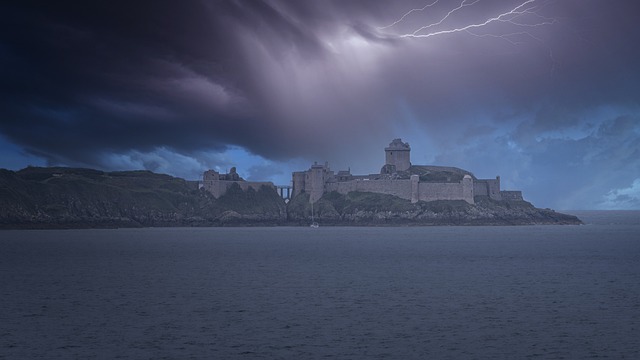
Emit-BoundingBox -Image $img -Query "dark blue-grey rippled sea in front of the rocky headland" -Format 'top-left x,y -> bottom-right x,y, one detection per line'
0,212 -> 640,359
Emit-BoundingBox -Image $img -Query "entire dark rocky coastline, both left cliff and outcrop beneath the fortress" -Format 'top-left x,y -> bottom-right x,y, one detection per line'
0,167 -> 581,229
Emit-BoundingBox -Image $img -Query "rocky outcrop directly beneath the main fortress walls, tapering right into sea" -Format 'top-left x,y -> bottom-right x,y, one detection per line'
287,192 -> 582,226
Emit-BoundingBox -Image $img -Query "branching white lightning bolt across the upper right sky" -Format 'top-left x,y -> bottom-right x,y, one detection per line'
378,0 -> 555,40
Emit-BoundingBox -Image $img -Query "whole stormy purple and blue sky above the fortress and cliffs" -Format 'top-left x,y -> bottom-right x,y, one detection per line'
0,0 -> 640,209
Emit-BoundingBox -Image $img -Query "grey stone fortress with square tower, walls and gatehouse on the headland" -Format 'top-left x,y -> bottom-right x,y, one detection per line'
200,139 -> 522,204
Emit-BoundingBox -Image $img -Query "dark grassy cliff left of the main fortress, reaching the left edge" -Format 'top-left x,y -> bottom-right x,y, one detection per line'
0,167 -> 285,228
